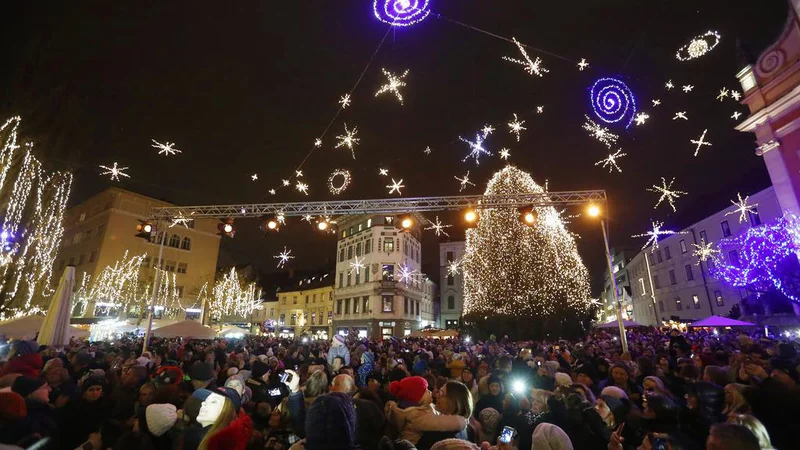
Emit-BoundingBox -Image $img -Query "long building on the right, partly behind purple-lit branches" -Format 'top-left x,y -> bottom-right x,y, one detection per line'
627,187 -> 782,325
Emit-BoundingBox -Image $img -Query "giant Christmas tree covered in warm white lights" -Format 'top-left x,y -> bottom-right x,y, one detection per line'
463,166 -> 591,337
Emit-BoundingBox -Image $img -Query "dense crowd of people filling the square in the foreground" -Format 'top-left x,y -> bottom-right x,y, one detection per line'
0,329 -> 800,450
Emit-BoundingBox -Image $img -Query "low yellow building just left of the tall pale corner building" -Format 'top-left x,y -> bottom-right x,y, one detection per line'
276,273 -> 334,339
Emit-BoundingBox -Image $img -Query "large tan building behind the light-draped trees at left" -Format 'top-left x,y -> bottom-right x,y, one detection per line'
54,188 -> 220,319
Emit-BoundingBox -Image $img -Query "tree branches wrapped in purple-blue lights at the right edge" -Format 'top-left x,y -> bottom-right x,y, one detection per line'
707,212 -> 800,303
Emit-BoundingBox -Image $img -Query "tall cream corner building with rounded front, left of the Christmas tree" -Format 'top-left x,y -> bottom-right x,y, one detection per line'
334,215 -> 436,339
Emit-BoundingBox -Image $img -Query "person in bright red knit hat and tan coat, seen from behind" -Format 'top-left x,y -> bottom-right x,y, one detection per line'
384,377 -> 467,444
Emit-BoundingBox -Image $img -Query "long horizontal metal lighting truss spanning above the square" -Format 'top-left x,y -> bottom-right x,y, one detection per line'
150,190 -> 606,220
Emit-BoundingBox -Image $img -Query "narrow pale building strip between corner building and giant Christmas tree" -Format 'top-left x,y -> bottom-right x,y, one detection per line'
437,241 -> 466,329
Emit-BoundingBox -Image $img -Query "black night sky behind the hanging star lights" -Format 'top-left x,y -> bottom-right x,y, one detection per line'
0,0 -> 788,294
